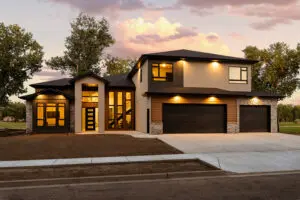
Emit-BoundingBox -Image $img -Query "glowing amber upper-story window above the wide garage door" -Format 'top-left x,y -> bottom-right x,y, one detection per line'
152,63 -> 173,82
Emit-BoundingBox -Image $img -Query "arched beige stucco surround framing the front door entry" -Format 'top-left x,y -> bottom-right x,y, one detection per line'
75,77 -> 105,133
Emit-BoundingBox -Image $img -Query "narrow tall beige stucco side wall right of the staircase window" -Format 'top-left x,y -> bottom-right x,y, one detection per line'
132,61 -> 150,133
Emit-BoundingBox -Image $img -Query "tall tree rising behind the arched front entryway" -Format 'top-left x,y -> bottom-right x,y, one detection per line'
46,13 -> 114,76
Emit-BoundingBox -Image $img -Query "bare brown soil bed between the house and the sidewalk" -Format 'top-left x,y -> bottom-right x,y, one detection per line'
0,134 -> 182,161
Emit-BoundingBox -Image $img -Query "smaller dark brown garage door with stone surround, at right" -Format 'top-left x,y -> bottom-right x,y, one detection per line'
240,106 -> 270,132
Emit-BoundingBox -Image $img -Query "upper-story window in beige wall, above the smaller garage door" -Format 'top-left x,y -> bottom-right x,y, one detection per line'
229,67 -> 248,84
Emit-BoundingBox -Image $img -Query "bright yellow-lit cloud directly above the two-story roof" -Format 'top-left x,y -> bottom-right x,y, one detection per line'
110,17 -> 229,56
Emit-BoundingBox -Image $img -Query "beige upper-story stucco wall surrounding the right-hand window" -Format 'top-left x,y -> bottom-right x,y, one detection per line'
183,61 -> 251,91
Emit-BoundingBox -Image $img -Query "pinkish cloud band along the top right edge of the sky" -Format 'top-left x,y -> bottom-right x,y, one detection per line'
177,0 -> 300,30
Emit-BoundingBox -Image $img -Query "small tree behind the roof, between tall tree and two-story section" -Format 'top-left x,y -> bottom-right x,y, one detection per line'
104,55 -> 137,76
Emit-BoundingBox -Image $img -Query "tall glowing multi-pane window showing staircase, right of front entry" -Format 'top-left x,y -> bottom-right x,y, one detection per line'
108,91 -> 134,129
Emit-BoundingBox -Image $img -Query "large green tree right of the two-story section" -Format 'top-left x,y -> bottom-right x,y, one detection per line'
243,42 -> 300,97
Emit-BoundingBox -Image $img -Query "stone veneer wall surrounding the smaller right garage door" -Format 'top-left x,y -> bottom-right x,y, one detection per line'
237,98 -> 278,133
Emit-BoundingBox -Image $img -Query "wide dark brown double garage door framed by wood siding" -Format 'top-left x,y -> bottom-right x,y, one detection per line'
163,104 -> 227,133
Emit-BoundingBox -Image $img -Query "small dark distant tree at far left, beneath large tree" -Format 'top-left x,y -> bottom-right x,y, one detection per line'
3,102 -> 26,121
